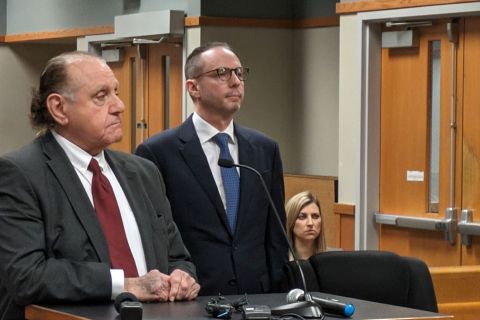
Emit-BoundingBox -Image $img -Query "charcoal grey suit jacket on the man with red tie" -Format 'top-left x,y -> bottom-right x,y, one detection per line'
0,133 -> 195,319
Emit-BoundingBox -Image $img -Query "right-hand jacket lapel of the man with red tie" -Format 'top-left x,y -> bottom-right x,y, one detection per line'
105,150 -> 158,270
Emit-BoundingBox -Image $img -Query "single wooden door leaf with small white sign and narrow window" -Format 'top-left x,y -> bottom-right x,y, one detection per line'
379,20 -> 461,266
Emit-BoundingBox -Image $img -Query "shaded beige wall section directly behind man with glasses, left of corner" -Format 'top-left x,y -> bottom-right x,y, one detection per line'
187,27 -> 294,171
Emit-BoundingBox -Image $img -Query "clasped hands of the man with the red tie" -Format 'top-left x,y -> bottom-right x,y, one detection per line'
125,269 -> 200,301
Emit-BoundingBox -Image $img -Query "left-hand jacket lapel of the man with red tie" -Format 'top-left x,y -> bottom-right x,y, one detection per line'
42,132 -> 110,263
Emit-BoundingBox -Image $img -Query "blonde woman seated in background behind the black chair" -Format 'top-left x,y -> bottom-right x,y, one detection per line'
285,191 -> 326,260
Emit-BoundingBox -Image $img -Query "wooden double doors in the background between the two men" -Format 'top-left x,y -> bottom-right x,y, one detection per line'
109,42 -> 183,152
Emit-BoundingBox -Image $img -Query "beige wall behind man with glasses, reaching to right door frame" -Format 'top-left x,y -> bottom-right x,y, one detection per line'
186,27 -> 338,176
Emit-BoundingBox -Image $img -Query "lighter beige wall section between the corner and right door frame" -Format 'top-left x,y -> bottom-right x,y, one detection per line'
291,27 -> 339,176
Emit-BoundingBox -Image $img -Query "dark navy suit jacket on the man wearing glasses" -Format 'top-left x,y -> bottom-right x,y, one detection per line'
136,117 -> 287,295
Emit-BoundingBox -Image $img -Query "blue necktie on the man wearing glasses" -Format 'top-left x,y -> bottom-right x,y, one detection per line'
213,133 -> 240,233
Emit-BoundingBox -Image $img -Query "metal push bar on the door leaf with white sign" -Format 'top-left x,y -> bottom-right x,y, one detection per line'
374,208 -> 456,245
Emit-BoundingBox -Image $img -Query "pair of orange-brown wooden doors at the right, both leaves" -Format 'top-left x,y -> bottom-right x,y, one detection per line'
379,17 -> 480,267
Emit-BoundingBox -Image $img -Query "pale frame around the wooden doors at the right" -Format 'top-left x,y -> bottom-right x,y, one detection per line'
346,3 -> 480,250
